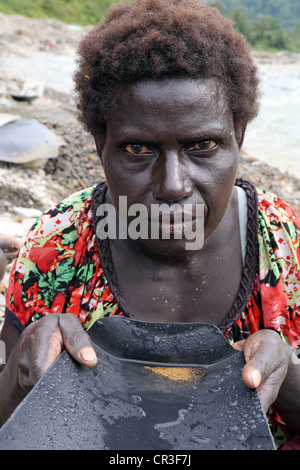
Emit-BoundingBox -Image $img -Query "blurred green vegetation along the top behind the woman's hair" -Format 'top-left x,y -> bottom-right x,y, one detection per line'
0,0 -> 300,52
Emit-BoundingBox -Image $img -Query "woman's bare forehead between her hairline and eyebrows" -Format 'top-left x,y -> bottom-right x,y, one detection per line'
107,78 -> 233,137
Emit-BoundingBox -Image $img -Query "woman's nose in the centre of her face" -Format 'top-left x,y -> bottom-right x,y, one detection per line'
153,152 -> 193,202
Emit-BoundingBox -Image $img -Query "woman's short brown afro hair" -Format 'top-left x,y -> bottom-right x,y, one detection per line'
74,0 -> 259,136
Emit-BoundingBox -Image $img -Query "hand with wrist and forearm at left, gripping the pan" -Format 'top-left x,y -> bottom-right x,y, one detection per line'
0,313 -> 97,426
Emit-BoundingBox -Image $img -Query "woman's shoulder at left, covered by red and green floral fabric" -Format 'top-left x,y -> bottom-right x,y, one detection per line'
6,188 -> 100,331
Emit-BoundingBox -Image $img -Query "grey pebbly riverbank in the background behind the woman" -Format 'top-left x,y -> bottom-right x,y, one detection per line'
0,13 -> 300,324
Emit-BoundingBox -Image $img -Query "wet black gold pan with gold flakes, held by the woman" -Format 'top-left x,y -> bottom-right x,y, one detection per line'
0,317 -> 275,451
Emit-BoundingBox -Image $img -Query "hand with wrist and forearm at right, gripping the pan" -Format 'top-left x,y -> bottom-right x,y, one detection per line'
233,330 -> 300,433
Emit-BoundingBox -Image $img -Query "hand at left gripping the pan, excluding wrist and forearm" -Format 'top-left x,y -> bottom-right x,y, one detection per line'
16,313 -> 97,392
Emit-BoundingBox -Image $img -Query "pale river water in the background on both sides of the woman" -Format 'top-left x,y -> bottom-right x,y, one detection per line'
0,51 -> 300,178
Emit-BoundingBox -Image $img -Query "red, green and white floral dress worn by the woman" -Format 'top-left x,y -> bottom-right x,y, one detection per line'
5,179 -> 300,446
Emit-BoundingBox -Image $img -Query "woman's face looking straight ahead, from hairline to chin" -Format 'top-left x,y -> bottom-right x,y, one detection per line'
95,78 -> 239,255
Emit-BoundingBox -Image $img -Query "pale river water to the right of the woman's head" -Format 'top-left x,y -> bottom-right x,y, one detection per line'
244,60 -> 300,177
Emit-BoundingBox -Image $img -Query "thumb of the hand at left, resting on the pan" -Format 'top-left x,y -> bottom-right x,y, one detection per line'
59,313 -> 97,366
